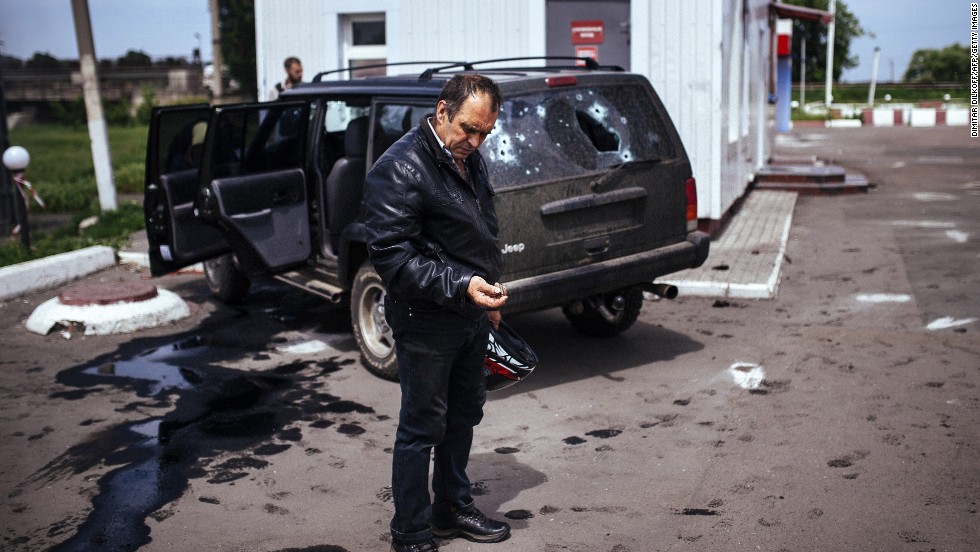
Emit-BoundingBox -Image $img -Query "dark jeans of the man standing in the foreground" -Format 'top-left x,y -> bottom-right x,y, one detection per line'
385,298 -> 490,542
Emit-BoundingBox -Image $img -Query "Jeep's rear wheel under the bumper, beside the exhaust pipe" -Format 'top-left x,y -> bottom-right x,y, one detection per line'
562,287 -> 643,337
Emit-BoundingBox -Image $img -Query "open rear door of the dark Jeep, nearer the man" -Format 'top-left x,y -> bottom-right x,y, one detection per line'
195,102 -> 314,275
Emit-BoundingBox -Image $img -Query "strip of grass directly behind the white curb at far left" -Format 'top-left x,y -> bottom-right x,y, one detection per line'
0,202 -> 144,266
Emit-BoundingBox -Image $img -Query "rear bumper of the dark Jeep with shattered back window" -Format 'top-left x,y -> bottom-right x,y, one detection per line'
504,231 -> 711,313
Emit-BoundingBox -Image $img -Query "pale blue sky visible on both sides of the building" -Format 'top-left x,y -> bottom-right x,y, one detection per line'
0,0 -> 970,82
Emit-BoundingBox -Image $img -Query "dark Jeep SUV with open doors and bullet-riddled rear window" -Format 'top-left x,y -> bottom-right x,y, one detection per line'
144,58 -> 709,379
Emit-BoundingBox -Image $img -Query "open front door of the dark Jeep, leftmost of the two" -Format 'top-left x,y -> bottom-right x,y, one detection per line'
143,105 -> 230,276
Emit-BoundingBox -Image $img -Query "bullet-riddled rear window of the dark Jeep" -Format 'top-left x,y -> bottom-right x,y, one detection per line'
483,84 -> 674,189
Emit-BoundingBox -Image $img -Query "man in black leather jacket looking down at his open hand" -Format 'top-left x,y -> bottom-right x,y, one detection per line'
363,74 -> 510,552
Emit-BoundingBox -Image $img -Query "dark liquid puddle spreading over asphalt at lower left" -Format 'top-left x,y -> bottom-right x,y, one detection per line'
37,337 -> 368,551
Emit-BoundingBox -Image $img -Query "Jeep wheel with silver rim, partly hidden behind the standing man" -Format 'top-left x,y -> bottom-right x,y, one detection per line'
350,262 -> 398,381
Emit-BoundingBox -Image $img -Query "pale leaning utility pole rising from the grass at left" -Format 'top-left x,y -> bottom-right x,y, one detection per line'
71,0 -> 116,211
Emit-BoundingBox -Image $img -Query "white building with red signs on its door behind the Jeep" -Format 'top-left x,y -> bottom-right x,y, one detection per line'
255,0 -> 815,229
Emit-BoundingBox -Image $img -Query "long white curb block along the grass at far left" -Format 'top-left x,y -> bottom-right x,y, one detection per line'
0,245 -> 116,301
